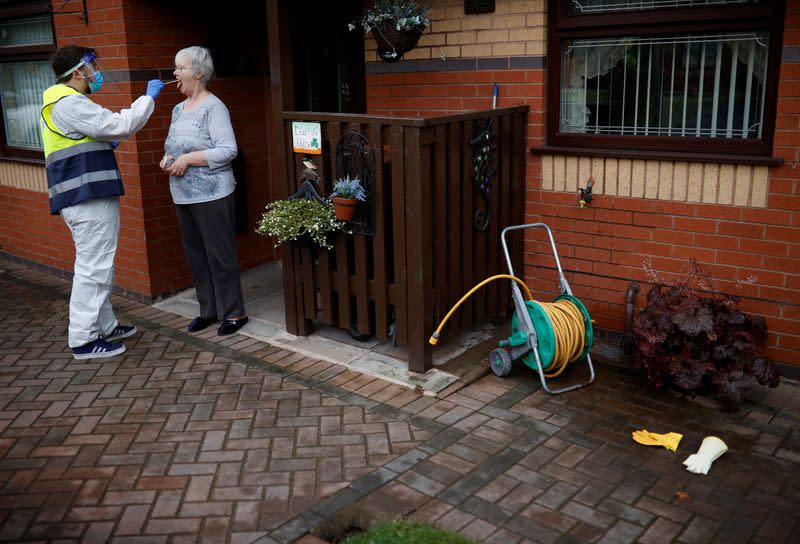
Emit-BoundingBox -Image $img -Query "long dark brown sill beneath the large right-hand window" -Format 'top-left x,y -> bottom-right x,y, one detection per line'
530,145 -> 783,166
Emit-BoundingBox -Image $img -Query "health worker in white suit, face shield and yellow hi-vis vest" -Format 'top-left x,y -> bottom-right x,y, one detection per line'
40,45 -> 164,359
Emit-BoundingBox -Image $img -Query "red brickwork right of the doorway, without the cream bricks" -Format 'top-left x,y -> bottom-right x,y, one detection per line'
367,6 -> 800,365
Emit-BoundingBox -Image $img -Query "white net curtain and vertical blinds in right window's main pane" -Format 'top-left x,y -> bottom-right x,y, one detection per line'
560,32 -> 769,138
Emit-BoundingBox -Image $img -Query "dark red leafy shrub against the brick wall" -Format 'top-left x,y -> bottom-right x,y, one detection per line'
633,259 -> 780,410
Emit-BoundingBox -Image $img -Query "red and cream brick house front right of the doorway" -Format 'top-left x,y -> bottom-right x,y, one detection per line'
366,0 -> 800,374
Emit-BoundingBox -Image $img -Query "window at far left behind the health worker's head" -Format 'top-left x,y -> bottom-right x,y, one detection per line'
0,2 -> 55,159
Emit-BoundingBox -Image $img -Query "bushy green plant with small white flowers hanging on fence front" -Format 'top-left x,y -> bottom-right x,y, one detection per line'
256,198 -> 344,249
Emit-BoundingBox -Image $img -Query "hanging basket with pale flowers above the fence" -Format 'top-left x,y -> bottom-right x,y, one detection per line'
347,0 -> 431,62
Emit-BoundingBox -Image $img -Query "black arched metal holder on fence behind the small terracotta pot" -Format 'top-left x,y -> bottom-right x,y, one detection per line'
334,130 -> 375,236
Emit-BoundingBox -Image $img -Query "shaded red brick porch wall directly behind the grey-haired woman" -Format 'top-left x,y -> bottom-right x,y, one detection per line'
120,2 -> 275,294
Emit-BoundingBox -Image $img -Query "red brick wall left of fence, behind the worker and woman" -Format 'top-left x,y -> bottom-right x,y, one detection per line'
0,0 -> 275,296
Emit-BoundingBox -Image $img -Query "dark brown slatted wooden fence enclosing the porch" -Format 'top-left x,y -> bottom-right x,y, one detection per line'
279,106 -> 528,372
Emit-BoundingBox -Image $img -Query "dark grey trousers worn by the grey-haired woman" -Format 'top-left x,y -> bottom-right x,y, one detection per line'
175,193 -> 245,319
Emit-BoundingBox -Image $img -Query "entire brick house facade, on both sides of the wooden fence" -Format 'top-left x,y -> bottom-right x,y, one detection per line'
0,0 -> 800,367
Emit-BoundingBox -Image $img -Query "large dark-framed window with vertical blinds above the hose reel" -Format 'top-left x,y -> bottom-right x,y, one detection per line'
548,0 -> 784,156
